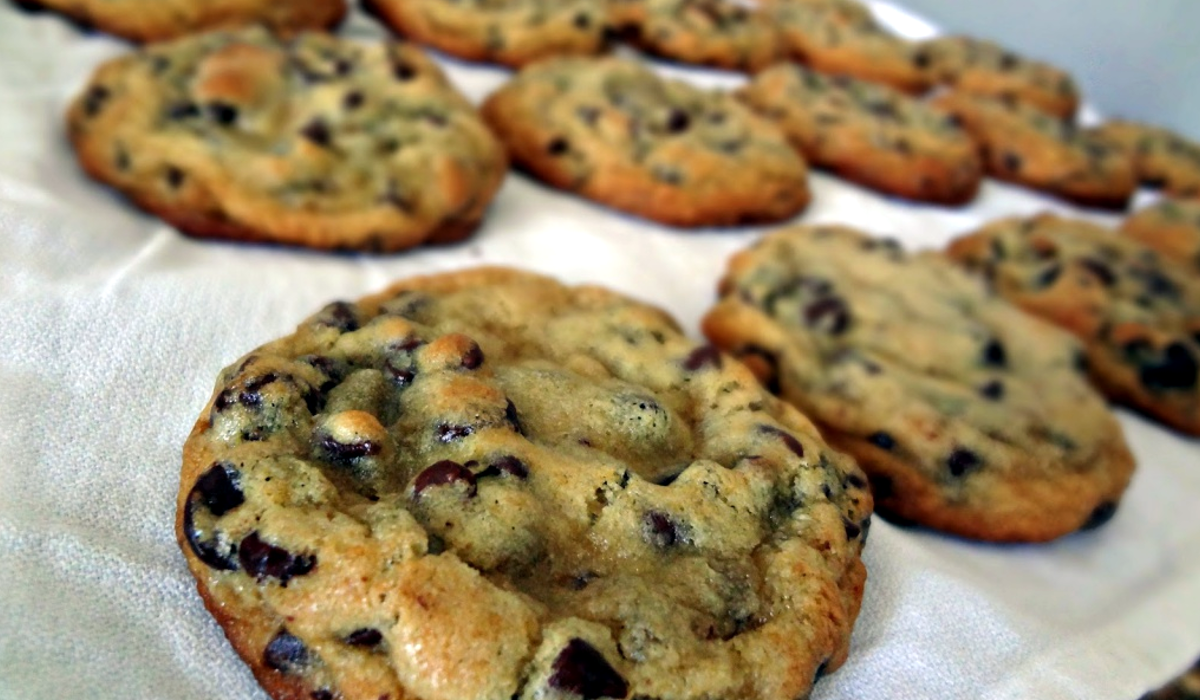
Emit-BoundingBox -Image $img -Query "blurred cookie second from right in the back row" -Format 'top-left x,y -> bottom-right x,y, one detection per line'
763,0 -> 930,94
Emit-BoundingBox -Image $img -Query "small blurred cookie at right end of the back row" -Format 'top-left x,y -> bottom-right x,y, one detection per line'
917,36 -> 1079,120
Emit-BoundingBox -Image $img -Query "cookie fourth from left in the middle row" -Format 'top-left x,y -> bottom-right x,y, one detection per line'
932,92 -> 1138,210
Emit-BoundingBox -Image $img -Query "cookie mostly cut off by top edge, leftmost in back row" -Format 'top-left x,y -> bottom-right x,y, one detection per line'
13,0 -> 347,42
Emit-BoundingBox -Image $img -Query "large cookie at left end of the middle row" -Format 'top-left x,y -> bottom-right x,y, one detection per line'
67,29 -> 508,251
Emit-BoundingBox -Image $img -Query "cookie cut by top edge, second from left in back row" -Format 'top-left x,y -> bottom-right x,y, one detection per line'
362,0 -> 608,67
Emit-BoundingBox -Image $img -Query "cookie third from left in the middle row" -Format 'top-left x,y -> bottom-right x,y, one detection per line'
738,64 -> 983,204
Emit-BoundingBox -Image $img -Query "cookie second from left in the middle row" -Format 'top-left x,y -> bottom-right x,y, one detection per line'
482,58 -> 810,227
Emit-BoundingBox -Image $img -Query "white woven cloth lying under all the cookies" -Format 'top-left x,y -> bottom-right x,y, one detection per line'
0,5 -> 1200,700
